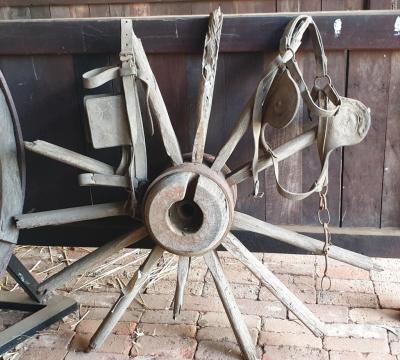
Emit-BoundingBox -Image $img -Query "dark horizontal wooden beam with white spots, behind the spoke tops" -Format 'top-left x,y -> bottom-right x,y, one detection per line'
0,11 -> 400,55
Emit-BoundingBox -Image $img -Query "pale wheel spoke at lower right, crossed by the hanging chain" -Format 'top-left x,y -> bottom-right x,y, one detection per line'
233,211 -> 381,270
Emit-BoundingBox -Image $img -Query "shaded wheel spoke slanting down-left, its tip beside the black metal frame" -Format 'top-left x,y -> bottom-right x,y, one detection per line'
38,226 -> 148,295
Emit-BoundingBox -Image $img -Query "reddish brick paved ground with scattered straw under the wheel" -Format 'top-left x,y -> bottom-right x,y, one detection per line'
0,248 -> 400,360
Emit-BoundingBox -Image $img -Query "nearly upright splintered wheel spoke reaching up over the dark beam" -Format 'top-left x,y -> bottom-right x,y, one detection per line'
192,7 -> 223,164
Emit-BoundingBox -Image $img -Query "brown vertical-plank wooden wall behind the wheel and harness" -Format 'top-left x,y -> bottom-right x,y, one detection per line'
0,0 -> 400,255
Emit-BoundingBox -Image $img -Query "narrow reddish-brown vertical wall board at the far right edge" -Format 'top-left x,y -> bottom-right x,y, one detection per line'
381,51 -> 400,227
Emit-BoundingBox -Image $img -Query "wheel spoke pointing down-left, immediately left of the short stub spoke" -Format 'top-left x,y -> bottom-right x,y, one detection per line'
89,246 -> 164,350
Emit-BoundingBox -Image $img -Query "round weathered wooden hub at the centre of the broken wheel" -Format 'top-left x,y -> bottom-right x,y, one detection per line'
144,163 -> 235,256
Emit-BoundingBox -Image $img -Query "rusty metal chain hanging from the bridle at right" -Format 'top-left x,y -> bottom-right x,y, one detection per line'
318,185 -> 332,291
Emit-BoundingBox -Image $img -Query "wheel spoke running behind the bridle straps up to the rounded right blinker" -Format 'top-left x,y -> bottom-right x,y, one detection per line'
226,128 -> 317,185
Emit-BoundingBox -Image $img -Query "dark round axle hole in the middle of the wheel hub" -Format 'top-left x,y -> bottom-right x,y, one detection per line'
169,200 -> 204,233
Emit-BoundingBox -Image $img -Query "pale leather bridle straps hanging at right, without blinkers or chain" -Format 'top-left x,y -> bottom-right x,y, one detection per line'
252,15 -> 341,200
